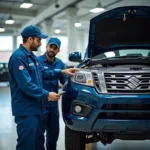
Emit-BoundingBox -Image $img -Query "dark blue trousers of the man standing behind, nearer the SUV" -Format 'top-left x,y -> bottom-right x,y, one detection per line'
40,107 -> 59,150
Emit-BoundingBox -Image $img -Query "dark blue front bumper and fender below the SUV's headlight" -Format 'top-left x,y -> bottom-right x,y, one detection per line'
62,80 -> 150,132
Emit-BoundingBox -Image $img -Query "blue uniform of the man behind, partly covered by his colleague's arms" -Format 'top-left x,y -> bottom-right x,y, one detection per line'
38,53 -> 68,150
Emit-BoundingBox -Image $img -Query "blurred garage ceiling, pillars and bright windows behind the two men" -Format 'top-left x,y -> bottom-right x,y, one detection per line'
0,0 -> 150,65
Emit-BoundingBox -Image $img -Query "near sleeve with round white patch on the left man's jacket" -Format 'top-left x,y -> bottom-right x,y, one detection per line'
9,56 -> 49,99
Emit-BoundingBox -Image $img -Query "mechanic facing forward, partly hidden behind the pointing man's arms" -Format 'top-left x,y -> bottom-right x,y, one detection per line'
38,37 -> 67,150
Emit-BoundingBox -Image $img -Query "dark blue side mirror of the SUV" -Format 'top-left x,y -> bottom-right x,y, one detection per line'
69,52 -> 82,62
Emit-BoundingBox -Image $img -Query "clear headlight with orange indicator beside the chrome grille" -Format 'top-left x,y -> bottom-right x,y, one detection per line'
71,71 -> 93,86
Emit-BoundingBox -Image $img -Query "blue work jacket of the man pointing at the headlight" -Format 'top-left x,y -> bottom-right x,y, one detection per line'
8,45 -> 61,116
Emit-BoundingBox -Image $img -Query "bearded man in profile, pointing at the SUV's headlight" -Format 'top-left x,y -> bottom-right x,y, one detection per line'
8,25 -> 77,150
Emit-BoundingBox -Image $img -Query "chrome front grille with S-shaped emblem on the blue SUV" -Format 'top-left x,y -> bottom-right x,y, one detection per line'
92,68 -> 150,94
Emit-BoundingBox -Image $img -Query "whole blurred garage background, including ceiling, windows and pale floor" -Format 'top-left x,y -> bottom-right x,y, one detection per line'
0,0 -> 150,150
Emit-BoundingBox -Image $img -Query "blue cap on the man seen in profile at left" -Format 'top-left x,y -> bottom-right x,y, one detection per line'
21,25 -> 48,39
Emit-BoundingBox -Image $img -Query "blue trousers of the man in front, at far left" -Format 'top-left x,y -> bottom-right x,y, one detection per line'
15,116 -> 40,150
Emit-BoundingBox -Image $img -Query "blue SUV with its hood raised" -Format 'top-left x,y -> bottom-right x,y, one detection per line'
62,6 -> 150,150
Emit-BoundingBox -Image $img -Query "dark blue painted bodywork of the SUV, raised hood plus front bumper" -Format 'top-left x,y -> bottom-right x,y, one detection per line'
62,6 -> 150,137
